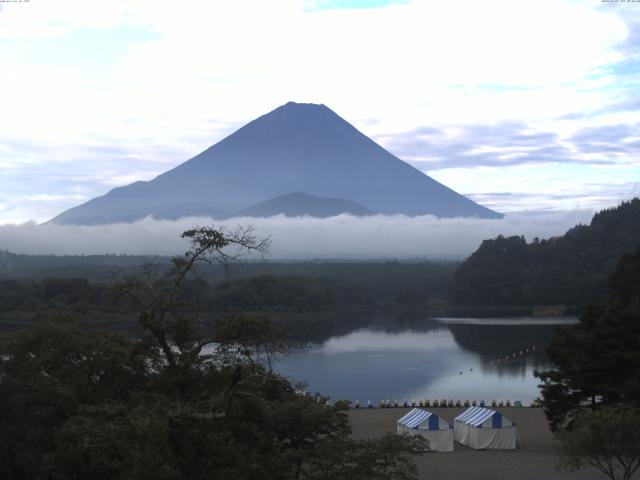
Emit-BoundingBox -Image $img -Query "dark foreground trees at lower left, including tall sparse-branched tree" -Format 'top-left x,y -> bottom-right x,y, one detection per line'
0,228 -> 426,480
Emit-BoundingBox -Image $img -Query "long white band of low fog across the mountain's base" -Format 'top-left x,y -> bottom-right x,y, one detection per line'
0,210 -> 593,260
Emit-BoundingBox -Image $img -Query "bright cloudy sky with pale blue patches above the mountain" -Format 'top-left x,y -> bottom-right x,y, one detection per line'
0,0 -> 640,224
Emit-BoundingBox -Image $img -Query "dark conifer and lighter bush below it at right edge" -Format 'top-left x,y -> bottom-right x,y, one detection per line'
537,249 -> 640,480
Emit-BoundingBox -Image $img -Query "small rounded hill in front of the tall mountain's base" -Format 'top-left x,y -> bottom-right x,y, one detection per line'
233,192 -> 373,218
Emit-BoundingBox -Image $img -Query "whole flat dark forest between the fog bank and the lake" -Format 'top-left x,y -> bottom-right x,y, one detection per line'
0,252 -> 456,341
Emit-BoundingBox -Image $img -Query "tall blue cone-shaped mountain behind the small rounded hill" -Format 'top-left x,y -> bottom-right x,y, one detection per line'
52,102 -> 502,224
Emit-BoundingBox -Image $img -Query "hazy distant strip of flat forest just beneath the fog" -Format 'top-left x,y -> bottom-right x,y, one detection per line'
0,251 -> 458,299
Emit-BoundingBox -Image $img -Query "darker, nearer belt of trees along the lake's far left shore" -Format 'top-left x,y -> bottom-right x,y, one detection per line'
0,275 -> 374,339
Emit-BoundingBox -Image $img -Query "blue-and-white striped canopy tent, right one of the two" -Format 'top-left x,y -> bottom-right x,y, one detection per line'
453,407 -> 520,450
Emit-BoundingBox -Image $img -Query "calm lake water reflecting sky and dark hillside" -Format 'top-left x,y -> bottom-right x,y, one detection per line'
275,318 -> 575,405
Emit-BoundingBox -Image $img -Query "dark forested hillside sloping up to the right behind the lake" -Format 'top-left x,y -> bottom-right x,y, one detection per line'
451,198 -> 640,307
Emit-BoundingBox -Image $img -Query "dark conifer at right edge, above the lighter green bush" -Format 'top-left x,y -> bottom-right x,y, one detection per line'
537,249 -> 640,429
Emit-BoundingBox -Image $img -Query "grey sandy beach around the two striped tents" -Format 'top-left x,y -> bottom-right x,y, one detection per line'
349,408 -> 608,480
